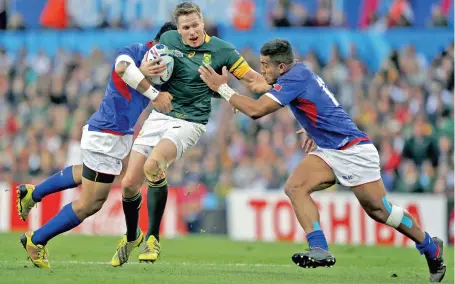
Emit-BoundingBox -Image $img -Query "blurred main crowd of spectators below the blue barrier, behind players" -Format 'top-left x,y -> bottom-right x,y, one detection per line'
0,40 -> 454,202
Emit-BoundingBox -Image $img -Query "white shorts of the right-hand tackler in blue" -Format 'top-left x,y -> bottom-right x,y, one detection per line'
309,144 -> 381,187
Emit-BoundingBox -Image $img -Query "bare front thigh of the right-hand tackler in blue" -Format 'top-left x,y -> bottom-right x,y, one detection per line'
284,155 -> 335,197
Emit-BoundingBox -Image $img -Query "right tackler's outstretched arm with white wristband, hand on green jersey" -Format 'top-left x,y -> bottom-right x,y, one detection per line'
199,65 -> 282,119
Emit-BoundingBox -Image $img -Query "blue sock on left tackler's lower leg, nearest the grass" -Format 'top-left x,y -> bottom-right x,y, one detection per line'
32,203 -> 81,245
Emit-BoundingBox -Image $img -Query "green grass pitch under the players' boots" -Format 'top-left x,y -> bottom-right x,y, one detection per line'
0,233 -> 454,284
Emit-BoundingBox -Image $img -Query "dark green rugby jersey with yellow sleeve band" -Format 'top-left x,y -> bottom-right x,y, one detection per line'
160,31 -> 250,124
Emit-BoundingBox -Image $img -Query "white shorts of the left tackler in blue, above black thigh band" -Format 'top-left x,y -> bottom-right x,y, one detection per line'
81,125 -> 133,176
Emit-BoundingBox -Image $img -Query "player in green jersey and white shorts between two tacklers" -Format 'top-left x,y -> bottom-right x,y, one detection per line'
111,2 -> 271,266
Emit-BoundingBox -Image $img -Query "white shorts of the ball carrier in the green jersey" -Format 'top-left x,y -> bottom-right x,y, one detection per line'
133,111 -> 206,160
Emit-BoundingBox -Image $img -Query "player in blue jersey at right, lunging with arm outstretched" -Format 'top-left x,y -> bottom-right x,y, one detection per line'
199,39 -> 446,282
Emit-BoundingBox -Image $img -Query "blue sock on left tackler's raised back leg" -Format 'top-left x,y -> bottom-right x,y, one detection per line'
32,166 -> 77,202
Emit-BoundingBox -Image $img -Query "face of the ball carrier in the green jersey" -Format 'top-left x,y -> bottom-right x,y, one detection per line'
177,13 -> 205,47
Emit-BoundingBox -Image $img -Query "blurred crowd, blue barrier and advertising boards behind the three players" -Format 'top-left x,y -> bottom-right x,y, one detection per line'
0,0 -> 454,244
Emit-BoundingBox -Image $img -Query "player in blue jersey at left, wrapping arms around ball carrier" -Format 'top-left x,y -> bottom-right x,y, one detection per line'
17,23 -> 176,268
